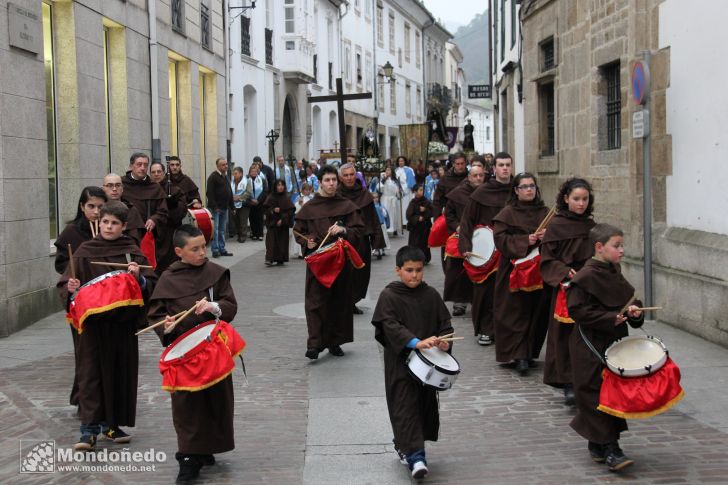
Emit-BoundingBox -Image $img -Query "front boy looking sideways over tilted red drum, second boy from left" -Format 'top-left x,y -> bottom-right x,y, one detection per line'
147,225 -> 238,483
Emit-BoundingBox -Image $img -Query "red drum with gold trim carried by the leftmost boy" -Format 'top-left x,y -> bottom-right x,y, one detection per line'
66,270 -> 144,334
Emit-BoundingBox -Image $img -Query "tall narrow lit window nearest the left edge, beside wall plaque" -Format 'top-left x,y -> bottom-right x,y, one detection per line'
41,2 -> 58,239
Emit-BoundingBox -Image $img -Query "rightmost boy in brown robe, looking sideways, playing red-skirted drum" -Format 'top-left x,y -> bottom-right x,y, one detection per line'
567,224 -> 644,471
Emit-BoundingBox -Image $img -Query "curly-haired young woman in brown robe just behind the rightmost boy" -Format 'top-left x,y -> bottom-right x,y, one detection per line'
539,178 -> 594,406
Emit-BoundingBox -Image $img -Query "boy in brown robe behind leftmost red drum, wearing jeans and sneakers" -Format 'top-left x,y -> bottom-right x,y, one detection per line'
57,201 -> 156,450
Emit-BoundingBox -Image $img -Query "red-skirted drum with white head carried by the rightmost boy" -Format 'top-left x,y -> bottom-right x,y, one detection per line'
597,335 -> 685,419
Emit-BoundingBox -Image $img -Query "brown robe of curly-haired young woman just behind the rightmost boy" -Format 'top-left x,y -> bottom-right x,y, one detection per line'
540,210 -> 594,387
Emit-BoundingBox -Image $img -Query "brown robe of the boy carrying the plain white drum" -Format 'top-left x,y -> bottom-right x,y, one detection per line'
372,281 -> 453,454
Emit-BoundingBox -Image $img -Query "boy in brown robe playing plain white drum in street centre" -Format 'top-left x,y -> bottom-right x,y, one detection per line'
372,246 -> 453,478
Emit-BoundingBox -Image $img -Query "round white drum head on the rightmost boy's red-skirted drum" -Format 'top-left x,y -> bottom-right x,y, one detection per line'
604,335 -> 667,377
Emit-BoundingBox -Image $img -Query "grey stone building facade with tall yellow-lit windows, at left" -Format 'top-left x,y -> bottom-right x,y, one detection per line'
0,0 -> 226,336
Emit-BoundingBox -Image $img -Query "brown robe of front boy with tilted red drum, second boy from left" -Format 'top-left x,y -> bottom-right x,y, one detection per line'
147,260 -> 238,455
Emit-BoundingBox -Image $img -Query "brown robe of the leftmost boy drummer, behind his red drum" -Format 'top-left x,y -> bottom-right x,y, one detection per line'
56,236 -> 157,426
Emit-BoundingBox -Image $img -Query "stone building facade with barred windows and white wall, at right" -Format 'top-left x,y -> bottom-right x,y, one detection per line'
520,0 -> 728,345
